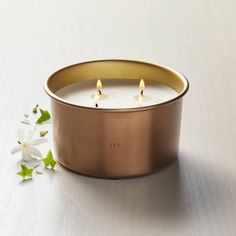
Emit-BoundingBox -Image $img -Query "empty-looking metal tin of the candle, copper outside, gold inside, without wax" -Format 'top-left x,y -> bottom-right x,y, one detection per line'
44,60 -> 189,178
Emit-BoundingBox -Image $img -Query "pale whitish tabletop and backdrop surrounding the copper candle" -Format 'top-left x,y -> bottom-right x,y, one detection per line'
0,0 -> 236,236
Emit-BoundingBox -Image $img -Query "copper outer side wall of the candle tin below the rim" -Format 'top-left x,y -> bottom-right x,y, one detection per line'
51,97 -> 182,178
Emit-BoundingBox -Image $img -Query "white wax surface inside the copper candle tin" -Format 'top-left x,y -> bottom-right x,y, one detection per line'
56,79 -> 178,109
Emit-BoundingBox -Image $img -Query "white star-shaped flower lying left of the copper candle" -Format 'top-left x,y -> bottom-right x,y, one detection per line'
11,129 -> 47,161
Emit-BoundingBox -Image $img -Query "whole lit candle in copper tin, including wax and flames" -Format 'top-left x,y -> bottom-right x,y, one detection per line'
44,60 -> 188,178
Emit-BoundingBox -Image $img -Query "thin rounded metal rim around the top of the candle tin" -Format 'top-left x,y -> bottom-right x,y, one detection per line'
44,59 -> 189,112
